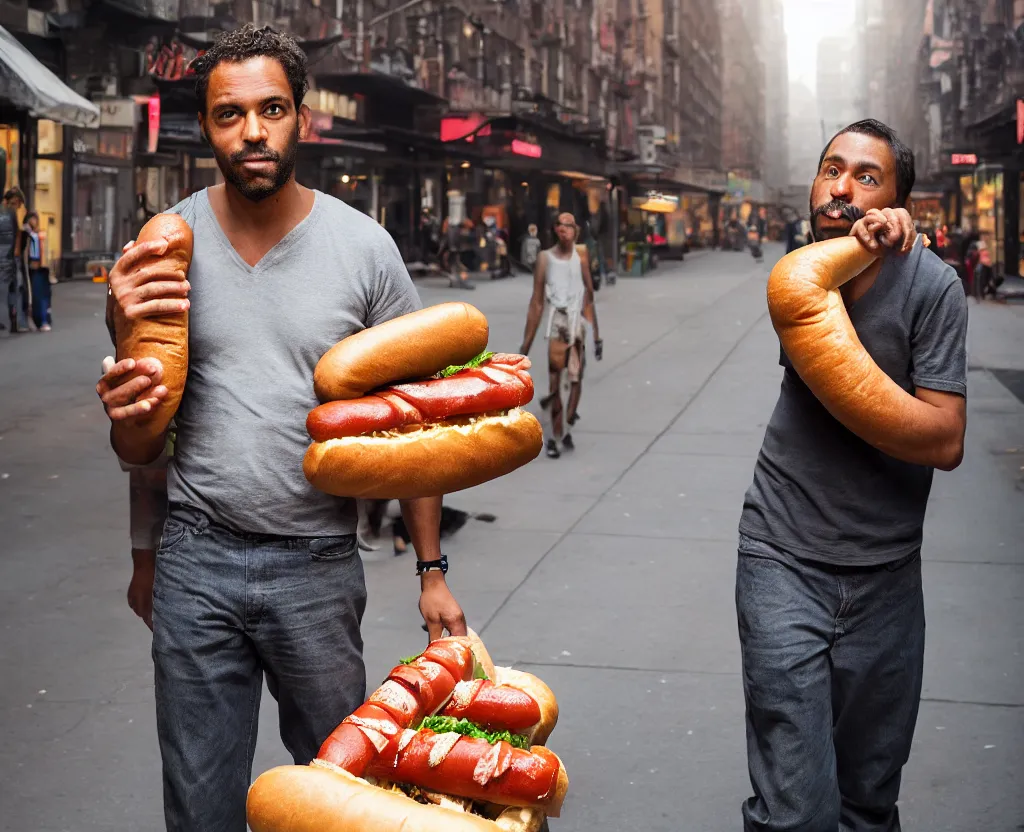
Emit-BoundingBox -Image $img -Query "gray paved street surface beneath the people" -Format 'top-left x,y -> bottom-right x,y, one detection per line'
0,241 -> 1024,832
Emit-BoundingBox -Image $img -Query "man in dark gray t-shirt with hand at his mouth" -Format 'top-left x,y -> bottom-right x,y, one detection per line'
736,120 -> 967,832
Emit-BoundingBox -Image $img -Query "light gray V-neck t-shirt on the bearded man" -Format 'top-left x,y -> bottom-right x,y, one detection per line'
167,191 -> 421,537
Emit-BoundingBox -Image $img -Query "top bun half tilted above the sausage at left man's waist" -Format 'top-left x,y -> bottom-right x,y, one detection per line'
313,303 -> 487,402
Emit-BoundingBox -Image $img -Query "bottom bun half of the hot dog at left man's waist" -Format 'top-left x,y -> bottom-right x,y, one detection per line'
302,407 -> 544,500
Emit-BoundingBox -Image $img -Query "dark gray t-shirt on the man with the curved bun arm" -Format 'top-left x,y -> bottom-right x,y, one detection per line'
739,237 -> 967,566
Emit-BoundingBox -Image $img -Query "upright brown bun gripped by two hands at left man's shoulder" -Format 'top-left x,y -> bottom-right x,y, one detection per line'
113,214 -> 193,448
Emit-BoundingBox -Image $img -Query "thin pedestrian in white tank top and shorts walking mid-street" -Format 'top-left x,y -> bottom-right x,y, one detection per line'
520,213 -> 604,459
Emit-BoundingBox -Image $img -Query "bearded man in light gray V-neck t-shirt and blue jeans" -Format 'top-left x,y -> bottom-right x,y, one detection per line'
97,26 -> 466,832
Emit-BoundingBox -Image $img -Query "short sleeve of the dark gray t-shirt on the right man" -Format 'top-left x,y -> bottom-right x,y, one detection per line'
910,280 -> 967,397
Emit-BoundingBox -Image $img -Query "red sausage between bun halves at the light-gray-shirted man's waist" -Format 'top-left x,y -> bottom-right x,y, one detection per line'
306,356 -> 534,442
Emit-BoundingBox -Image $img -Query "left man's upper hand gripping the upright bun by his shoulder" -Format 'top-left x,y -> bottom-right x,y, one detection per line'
108,240 -> 189,321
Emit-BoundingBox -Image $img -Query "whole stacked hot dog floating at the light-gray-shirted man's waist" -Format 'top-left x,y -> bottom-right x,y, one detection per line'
303,303 -> 542,499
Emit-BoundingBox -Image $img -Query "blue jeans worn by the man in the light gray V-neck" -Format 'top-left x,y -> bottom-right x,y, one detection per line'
153,506 -> 367,832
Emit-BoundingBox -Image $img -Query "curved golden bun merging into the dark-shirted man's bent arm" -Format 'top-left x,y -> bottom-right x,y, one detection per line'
768,237 -> 930,452
